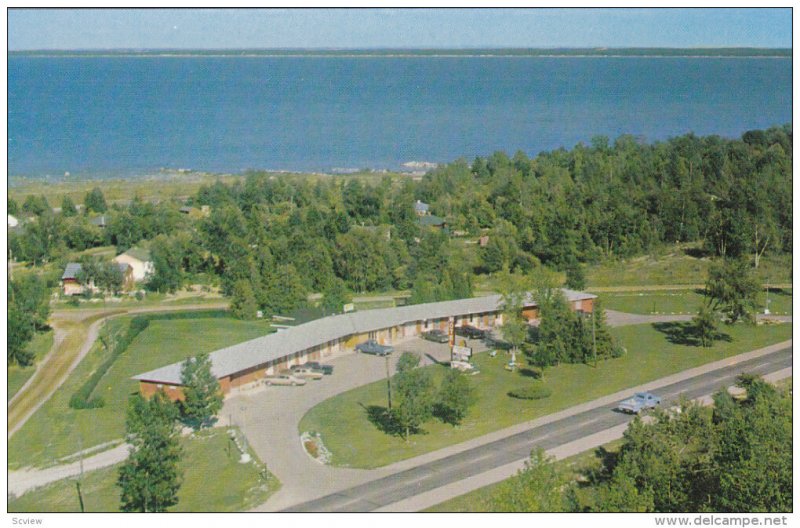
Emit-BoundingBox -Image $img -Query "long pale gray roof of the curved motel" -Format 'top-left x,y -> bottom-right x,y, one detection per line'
133,289 -> 597,385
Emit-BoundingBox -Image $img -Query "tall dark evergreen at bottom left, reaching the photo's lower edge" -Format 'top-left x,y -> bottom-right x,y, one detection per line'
117,392 -> 182,512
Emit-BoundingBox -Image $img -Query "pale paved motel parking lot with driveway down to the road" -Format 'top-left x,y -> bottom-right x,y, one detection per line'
220,337 -> 494,509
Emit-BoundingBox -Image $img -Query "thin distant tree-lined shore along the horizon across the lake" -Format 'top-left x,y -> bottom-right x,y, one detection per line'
9,48 -> 792,58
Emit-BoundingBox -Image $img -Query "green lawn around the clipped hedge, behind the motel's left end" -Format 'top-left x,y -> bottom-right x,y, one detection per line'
8,316 -> 271,469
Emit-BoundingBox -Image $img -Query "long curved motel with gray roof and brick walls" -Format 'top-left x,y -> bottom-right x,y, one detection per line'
133,289 -> 597,400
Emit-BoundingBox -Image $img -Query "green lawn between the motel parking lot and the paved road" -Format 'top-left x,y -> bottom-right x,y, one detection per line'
300,324 -> 792,468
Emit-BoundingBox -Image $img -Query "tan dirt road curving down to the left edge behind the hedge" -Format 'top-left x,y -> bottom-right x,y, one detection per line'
8,302 -> 228,438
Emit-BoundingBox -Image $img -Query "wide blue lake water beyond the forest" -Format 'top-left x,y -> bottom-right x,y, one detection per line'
8,57 -> 792,177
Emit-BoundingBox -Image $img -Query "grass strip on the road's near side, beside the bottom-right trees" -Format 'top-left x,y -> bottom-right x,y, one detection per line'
423,439 -> 622,513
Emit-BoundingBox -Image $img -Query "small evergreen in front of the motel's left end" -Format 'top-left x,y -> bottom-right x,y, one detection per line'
181,353 -> 222,429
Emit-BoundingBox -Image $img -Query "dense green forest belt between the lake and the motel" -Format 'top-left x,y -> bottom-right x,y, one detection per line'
9,125 -> 792,322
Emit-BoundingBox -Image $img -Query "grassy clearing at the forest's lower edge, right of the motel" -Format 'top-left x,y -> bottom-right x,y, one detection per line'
586,247 -> 792,288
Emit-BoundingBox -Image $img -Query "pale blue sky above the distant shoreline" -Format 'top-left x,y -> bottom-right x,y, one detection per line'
8,8 -> 792,50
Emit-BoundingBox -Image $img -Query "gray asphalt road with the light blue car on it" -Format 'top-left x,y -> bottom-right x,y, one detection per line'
285,347 -> 792,512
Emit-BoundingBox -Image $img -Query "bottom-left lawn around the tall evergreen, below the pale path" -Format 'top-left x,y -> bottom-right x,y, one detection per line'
8,428 -> 280,512
